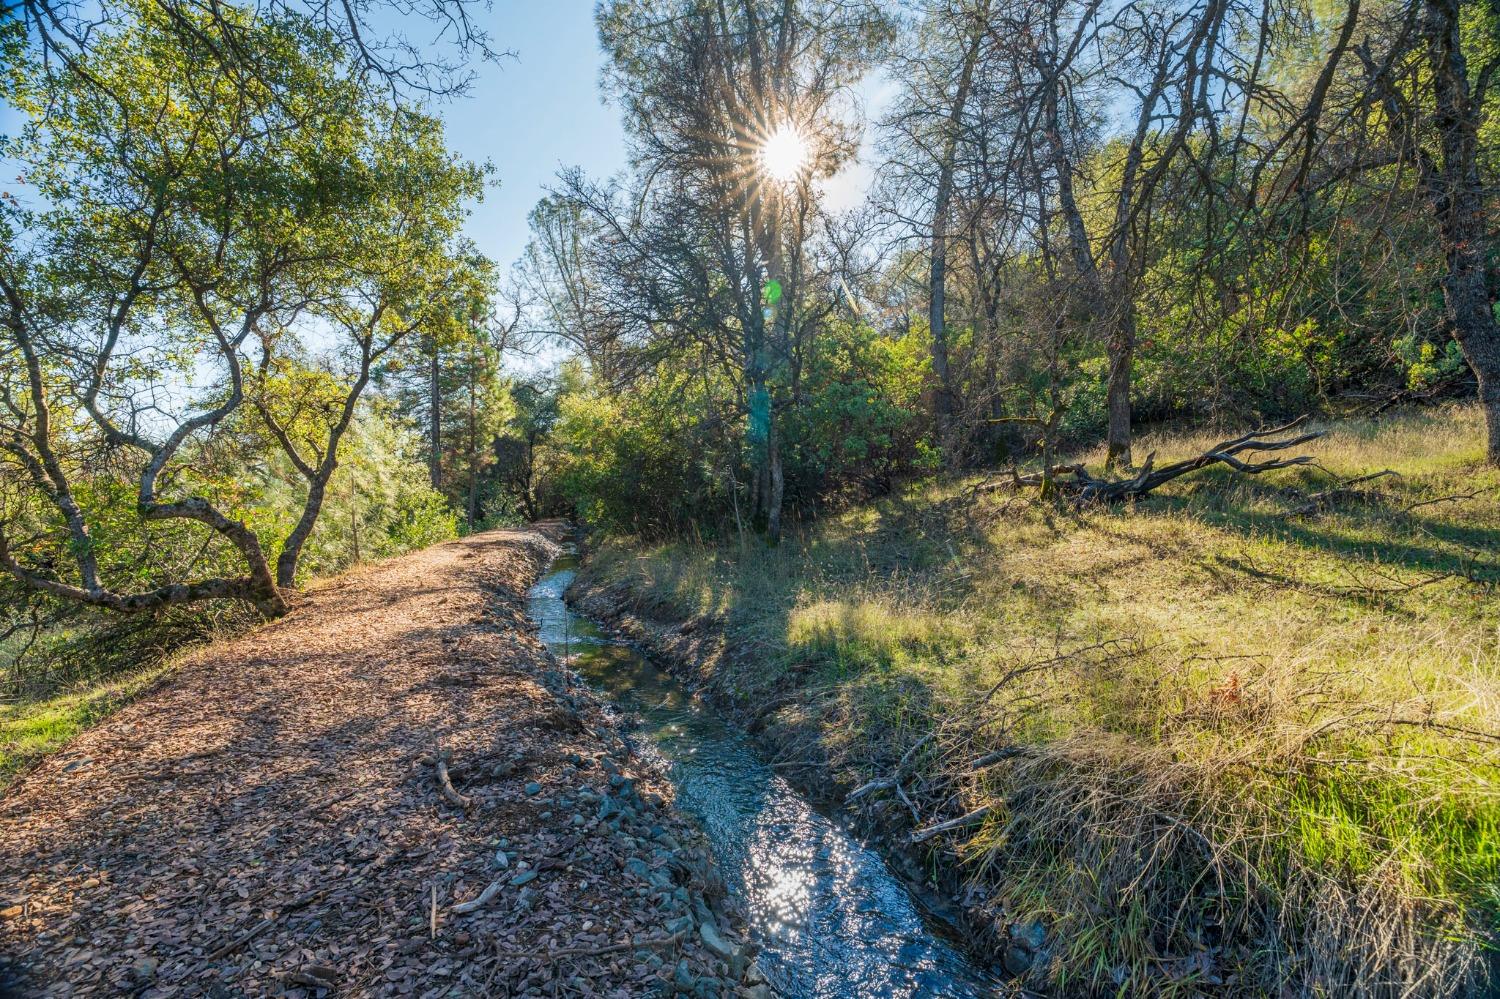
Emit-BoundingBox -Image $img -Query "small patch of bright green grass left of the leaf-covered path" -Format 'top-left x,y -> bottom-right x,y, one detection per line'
0,666 -> 168,791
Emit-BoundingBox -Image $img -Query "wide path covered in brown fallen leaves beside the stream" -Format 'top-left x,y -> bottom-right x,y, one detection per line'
0,530 -> 746,996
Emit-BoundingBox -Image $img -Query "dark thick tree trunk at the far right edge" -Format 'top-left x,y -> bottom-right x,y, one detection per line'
1419,0 -> 1500,465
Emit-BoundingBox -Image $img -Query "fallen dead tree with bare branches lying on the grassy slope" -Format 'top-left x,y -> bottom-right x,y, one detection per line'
1010,416 -> 1326,506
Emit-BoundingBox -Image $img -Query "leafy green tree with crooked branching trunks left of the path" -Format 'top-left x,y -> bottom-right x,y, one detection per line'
0,3 -> 479,615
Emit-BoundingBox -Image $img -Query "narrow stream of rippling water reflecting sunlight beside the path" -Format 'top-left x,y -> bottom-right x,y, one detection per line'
531,554 -> 998,999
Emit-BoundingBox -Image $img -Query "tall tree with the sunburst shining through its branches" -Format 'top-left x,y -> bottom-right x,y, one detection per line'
582,0 -> 888,543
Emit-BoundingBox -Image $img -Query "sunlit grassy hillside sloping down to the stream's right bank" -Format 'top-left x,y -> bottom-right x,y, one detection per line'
579,408 -> 1500,995
